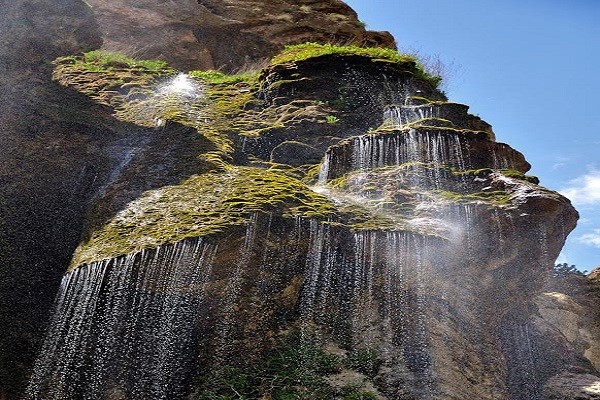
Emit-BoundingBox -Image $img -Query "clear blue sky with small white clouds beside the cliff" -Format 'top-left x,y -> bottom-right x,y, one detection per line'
346,0 -> 600,270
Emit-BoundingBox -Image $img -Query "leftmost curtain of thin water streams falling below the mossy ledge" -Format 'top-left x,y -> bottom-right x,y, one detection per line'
26,239 -> 216,400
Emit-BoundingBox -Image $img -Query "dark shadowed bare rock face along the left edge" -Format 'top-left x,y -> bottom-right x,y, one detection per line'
0,0 -> 103,399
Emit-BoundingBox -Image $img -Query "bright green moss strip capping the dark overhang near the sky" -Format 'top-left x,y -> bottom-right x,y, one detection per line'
271,43 -> 442,88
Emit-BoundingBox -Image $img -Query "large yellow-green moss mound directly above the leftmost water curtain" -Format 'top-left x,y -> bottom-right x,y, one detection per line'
72,166 -> 335,267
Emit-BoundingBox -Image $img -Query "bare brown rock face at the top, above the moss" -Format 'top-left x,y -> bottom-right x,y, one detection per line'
84,0 -> 395,71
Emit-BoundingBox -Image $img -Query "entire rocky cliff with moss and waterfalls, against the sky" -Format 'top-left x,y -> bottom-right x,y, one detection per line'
0,0 -> 600,399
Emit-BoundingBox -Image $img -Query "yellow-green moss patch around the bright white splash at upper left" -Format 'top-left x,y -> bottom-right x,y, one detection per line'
54,51 -> 251,166
